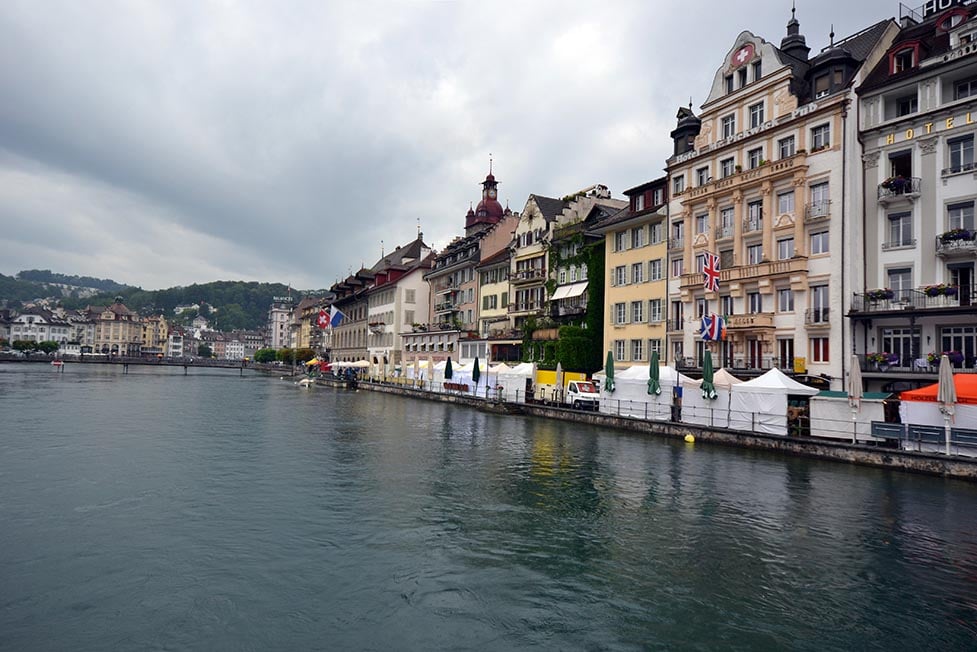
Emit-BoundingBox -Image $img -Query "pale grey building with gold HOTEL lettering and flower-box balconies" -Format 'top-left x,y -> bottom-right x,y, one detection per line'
849,2 -> 977,391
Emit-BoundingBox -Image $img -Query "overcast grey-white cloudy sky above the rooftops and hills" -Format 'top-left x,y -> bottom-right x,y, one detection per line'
0,0 -> 899,289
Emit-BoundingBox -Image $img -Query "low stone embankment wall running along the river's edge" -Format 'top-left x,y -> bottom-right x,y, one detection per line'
317,378 -> 977,482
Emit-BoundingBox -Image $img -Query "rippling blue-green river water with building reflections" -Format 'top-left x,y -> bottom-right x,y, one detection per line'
0,365 -> 977,650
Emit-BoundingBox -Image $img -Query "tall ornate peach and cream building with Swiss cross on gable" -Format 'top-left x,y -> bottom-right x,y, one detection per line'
667,10 -> 898,389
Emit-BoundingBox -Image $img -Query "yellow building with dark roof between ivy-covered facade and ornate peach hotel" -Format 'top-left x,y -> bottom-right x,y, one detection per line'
593,177 -> 668,367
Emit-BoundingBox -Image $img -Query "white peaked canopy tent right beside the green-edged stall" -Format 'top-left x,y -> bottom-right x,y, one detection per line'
729,369 -> 818,436
